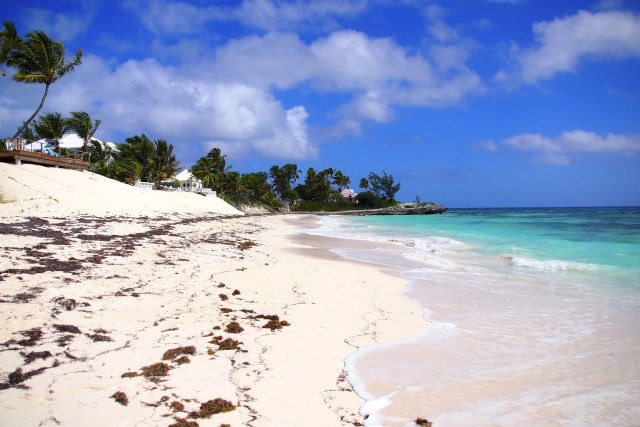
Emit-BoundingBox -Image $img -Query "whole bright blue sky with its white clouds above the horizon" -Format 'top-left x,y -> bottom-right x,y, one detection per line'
0,0 -> 640,207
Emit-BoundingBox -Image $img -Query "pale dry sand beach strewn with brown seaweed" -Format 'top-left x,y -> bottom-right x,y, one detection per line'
0,164 -> 424,426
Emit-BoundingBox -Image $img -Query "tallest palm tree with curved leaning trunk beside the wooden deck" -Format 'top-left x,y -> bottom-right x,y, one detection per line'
6,31 -> 82,138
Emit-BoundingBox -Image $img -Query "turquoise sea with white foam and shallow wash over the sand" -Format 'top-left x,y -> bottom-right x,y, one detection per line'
304,208 -> 640,426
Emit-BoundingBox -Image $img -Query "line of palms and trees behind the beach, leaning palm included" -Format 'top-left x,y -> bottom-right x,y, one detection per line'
0,21 -> 400,210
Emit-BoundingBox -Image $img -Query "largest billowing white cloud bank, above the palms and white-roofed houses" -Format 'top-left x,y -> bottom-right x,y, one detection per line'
0,0 -> 482,163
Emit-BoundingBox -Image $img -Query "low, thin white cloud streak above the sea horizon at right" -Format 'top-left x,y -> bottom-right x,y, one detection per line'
484,130 -> 640,165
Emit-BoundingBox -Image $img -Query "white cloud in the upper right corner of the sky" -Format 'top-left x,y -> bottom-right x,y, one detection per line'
517,11 -> 640,84
